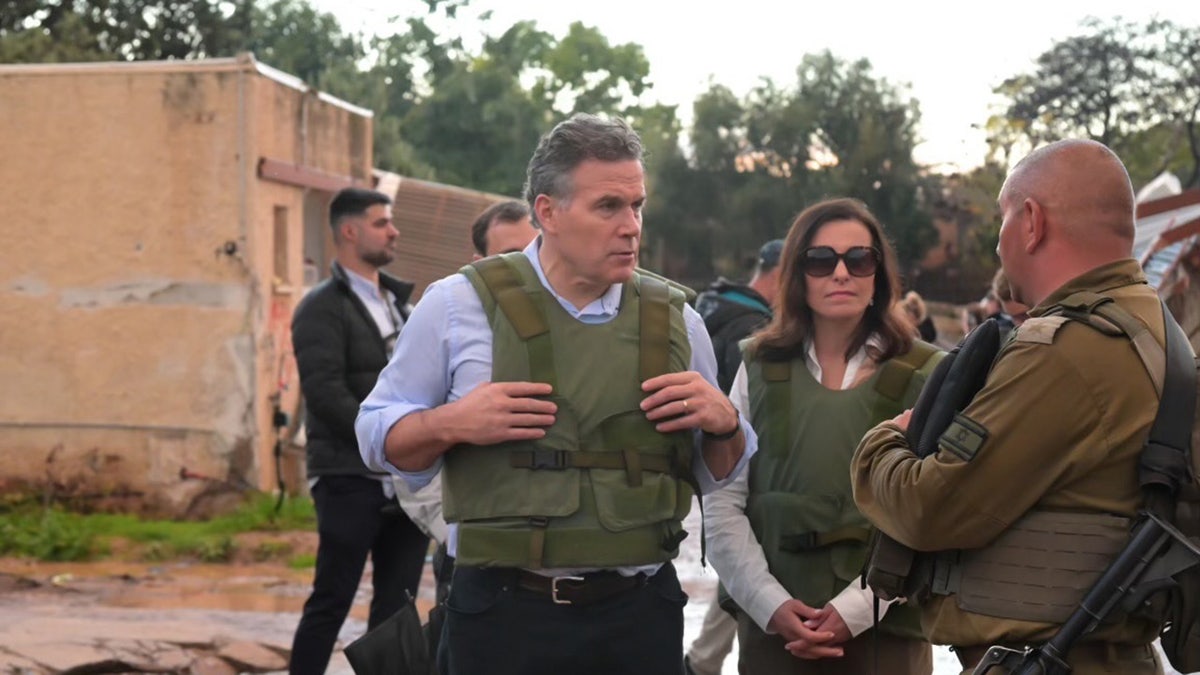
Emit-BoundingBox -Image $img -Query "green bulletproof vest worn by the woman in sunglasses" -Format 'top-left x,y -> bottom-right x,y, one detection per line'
745,341 -> 944,638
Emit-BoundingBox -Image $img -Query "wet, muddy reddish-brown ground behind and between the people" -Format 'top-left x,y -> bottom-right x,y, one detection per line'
0,509 -> 1161,675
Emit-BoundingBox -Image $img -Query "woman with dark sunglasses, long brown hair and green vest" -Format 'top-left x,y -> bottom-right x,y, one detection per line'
704,199 -> 941,675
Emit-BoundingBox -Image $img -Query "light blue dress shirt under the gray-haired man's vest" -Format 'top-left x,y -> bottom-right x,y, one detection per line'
354,237 -> 757,572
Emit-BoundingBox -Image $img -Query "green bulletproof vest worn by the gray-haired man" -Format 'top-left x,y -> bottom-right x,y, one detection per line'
443,253 -> 695,569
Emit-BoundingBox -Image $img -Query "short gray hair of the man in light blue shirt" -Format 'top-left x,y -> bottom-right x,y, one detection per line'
524,113 -> 643,227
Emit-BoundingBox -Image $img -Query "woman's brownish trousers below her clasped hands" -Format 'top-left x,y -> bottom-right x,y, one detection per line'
738,611 -> 934,675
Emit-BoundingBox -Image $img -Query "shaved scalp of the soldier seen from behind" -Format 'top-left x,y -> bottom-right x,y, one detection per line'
1004,139 -> 1134,243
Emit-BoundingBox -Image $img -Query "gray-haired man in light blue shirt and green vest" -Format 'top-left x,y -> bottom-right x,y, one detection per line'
356,114 -> 756,675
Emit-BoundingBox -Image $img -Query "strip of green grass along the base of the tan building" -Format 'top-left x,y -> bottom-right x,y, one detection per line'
0,487 -> 317,562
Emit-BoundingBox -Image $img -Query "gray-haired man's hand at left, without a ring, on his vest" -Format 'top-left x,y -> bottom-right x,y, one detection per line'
446,382 -> 558,446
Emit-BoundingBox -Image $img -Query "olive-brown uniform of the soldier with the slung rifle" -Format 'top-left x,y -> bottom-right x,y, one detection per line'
851,259 -> 1164,675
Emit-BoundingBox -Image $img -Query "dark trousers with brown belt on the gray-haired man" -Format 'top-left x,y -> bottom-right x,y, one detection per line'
443,563 -> 688,675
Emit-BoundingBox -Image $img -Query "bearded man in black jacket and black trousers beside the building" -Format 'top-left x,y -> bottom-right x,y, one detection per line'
288,187 -> 430,675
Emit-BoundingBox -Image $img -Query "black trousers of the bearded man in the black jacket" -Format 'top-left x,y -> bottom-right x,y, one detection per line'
288,476 -> 430,675
